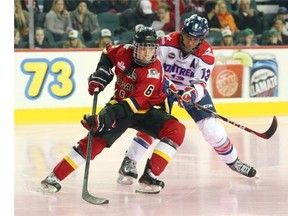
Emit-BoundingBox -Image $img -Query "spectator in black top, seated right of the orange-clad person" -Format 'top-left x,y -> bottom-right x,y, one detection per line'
233,0 -> 262,34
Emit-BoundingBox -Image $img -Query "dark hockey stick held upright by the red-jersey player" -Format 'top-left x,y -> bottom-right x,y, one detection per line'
82,88 -> 109,205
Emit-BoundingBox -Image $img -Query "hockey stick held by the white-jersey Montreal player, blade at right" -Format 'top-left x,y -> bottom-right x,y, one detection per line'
174,94 -> 278,139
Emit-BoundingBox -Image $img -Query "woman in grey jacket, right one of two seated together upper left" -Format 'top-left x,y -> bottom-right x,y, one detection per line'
70,0 -> 100,42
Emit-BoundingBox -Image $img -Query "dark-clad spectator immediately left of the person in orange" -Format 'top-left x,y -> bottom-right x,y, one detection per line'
203,1 -> 222,32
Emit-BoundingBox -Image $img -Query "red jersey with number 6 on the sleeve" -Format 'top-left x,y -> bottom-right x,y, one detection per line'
106,44 -> 166,113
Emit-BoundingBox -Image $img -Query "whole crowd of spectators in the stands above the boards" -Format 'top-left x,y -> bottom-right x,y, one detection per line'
14,0 -> 288,49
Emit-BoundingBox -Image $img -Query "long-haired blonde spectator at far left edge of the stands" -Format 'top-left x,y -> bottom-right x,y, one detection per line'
14,0 -> 29,41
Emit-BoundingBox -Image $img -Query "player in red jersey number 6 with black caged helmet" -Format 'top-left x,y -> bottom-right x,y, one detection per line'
41,27 -> 185,193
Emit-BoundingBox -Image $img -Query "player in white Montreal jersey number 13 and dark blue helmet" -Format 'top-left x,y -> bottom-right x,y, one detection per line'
117,15 -> 256,184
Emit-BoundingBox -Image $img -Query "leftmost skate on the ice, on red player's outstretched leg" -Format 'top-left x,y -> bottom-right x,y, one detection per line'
38,172 -> 61,193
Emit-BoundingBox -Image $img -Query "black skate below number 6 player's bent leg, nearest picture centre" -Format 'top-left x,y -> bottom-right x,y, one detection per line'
136,159 -> 165,194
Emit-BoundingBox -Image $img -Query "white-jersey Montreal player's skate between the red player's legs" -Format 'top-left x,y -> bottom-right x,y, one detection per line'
117,157 -> 138,185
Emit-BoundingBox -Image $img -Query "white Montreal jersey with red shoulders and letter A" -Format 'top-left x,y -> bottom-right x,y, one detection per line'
158,32 -> 215,102
